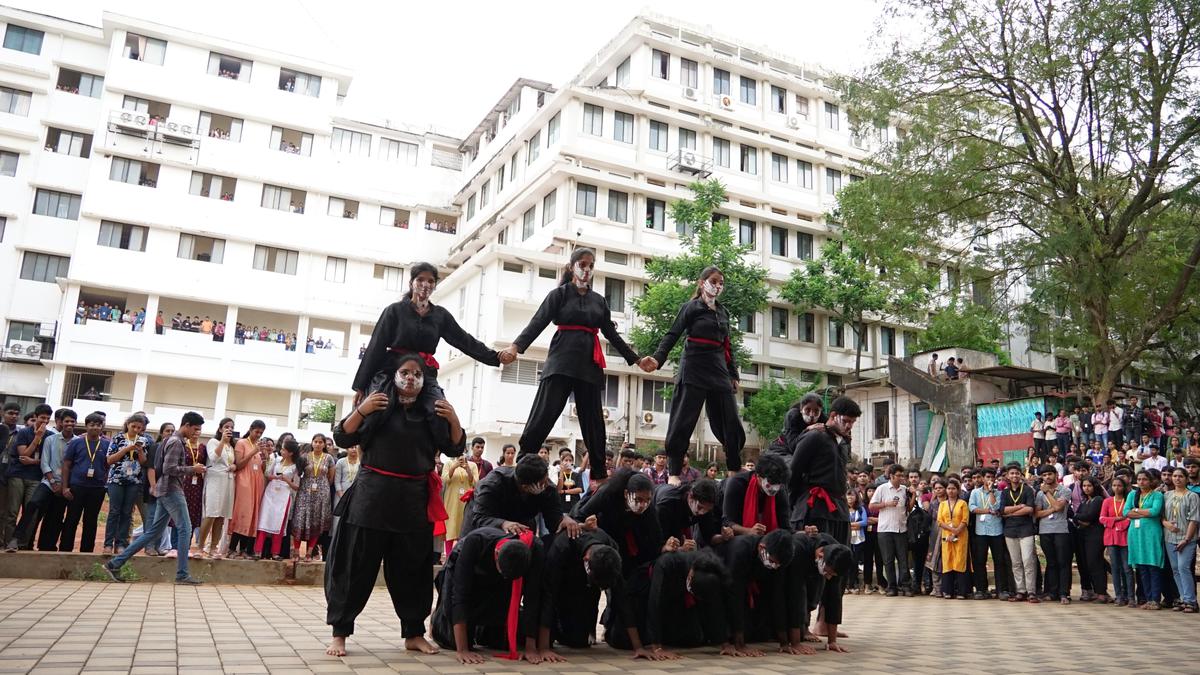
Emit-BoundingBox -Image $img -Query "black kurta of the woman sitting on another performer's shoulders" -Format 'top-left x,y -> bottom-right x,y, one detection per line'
343,299 -> 500,389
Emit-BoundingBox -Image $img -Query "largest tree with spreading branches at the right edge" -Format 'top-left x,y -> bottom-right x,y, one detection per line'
838,0 -> 1200,400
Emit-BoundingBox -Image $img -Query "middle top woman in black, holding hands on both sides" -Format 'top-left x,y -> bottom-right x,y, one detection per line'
500,249 -> 638,480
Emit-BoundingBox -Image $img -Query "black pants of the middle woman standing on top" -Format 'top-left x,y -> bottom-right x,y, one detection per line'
517,375 -> 609,479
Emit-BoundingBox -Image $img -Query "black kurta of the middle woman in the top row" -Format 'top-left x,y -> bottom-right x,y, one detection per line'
512,283 -> 637,387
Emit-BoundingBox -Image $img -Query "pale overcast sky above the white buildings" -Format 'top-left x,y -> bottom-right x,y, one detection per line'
32,0 -> 881,137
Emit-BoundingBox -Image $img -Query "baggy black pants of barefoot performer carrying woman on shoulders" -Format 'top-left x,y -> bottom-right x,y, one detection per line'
325,520 -> 433,638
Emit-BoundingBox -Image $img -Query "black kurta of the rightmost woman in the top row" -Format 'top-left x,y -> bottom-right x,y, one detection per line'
654,298 -> 738,392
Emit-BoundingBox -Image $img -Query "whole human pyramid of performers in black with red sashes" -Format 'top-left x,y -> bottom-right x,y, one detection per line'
325,247 -> 862,663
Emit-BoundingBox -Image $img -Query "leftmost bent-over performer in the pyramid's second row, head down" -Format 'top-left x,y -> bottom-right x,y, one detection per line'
460,455 -> 580,537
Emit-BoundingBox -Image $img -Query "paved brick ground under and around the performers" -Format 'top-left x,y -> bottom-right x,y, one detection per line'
0,571 -> 1200,675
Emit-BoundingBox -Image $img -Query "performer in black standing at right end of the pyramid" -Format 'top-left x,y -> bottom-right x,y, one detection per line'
788,396 -> 863,652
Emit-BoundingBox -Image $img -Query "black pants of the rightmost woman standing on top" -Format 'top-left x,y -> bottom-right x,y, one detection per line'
665,382 -> 746,476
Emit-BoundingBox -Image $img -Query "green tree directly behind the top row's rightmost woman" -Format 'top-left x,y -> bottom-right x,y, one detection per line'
630,179 -> 767,365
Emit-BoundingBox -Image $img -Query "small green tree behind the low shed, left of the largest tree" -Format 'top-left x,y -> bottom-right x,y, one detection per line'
779,238 -> 931,378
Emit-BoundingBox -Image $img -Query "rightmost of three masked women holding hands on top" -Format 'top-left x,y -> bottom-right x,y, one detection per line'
642,267 -> 746,478
